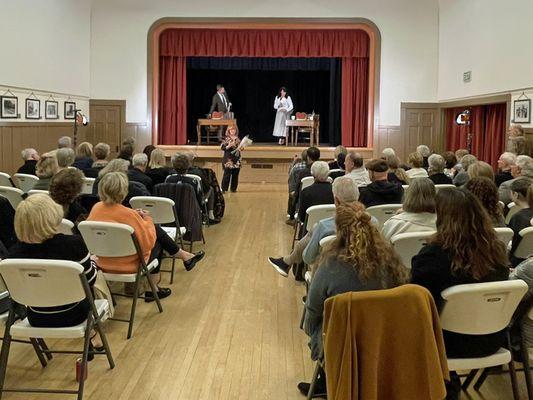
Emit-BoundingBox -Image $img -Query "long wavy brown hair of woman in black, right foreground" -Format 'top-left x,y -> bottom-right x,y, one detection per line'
429,188 -> 509,280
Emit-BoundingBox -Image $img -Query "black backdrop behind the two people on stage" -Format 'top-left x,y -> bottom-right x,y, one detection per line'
187,57 -> 341,146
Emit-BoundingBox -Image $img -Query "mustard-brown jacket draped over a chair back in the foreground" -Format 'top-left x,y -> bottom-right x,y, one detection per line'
324,285 -> 449,400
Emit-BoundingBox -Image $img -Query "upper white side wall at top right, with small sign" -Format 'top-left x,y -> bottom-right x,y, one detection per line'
438,0 -> 533,100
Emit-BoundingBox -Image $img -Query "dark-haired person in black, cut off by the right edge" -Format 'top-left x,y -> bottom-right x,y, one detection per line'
509,178 -> 533,266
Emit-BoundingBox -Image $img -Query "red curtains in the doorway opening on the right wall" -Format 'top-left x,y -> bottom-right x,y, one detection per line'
445,104 -> 507,168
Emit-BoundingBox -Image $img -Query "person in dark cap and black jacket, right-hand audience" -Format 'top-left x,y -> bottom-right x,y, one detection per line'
359,159 -> 403,207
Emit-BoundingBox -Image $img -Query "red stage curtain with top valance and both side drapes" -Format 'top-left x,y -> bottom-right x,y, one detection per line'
158,29 -> 369,147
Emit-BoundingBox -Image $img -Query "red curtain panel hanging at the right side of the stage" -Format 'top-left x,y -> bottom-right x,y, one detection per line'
341,57 -> 368,147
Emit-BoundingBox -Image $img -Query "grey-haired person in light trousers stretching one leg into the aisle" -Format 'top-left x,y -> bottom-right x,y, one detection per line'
268,176 -> 359,277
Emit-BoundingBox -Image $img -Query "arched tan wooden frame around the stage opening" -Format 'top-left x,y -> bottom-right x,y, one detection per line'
147,18 -> 381,148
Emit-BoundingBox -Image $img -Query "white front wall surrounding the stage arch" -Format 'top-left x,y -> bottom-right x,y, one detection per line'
90,0 -> 438,125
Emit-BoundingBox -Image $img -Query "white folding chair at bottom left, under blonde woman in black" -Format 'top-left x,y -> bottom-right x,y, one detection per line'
0,259 -> 115,399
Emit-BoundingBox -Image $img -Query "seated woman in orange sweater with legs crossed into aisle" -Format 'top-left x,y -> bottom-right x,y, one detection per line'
87,172 -> 205,301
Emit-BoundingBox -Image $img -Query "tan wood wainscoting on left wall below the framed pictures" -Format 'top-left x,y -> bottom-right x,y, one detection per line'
0,122 -> 88,175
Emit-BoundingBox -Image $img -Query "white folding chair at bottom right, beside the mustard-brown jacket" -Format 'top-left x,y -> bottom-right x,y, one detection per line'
440,280 -> 528,399
